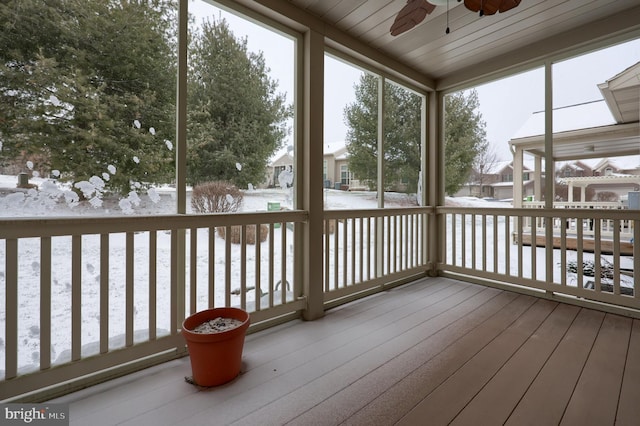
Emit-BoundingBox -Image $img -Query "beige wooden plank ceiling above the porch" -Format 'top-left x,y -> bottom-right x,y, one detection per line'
286,0 -> 640,88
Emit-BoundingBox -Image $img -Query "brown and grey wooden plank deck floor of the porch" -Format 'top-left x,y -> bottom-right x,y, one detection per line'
56,278 -> 640,426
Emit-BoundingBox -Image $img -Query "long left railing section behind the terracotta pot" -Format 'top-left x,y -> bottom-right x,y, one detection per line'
0,211 -> 307,400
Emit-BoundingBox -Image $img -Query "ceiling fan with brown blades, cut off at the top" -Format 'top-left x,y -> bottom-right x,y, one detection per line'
391,0 -> 521,36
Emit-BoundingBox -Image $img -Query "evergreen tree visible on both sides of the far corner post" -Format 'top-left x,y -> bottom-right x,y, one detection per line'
345,75 -> 486,194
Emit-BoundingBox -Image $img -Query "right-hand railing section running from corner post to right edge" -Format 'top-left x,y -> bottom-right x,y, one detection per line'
437,207 -> 640,310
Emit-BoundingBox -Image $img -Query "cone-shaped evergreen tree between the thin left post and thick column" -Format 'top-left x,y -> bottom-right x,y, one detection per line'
187,19 -> 292,188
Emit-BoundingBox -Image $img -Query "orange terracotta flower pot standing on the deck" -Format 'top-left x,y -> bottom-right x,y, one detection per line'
182,308 -> 249,386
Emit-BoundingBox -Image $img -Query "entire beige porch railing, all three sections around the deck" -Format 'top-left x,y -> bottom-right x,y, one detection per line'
0,207 -> 640,400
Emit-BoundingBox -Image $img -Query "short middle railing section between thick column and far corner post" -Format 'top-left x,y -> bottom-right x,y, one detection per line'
324,207 -> 433,302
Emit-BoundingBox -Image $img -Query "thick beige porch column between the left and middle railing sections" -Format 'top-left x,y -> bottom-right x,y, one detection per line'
296,30 -> 324,320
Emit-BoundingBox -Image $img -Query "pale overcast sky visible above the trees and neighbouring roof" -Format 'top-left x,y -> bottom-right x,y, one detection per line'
189,0 -> 640,159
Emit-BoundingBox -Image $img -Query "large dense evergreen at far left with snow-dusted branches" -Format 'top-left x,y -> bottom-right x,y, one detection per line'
0,0 -> 176,192
